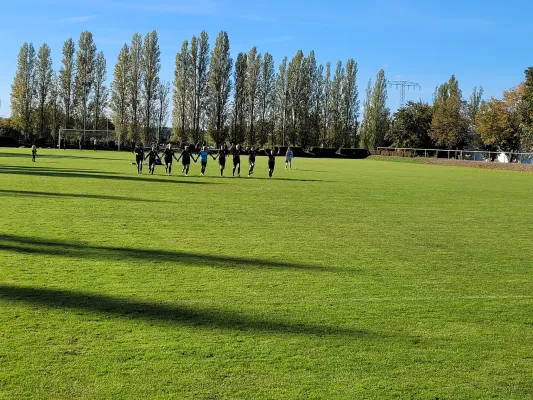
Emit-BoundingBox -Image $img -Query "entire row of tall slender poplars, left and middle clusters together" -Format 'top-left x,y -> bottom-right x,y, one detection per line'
11,31 -> 362,147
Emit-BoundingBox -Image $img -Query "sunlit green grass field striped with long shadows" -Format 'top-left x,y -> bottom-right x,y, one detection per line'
0,149 -> 533,399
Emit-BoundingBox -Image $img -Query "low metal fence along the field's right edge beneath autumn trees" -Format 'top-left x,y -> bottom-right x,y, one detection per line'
377,147 -> 533,164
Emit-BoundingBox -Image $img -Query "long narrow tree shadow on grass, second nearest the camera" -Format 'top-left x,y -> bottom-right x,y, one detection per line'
0,234 -> 340,272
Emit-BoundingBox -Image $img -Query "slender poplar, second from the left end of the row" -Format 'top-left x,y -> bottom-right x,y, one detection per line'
35,43 -> 53,137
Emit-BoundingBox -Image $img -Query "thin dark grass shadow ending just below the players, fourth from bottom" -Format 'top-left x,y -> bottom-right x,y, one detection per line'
0,167 -> 214,185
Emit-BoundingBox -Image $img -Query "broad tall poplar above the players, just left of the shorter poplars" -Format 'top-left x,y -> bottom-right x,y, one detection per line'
208,31 -> 233,144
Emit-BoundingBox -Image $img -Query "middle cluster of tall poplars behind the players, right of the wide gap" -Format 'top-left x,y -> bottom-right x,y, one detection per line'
172,31 -> 359,147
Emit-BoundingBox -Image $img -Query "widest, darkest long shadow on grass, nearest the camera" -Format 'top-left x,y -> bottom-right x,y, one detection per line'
0,284 -> 368,338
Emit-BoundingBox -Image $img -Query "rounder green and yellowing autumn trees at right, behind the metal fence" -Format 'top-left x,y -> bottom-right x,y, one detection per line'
383,71 -> 533,152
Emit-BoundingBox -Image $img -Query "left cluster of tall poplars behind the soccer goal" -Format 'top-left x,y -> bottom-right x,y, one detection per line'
11,31 -> 166,142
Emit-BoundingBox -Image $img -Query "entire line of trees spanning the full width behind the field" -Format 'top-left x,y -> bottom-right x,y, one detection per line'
7,31 -> 533,151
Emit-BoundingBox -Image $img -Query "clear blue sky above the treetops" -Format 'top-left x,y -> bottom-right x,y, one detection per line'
0,0 -> 533,116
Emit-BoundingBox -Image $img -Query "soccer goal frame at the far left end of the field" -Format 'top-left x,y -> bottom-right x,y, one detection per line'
57,129 -> 121,150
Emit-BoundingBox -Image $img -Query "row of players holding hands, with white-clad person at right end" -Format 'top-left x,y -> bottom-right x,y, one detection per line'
133,143 -> 294,178
